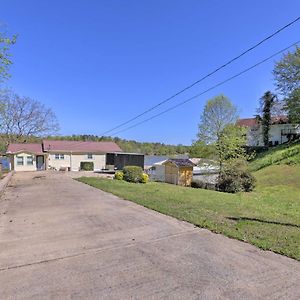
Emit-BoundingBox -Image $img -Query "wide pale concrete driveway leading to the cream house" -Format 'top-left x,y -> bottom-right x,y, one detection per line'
0,172 -> 300,299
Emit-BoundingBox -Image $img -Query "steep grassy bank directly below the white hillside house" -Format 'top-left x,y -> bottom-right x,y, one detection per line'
250,141 -> 300,171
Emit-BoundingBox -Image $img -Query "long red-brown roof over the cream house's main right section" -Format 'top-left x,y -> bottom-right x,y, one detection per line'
43,140 -> 122,153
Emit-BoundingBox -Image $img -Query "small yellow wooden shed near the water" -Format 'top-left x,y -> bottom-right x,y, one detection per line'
163,158 -> 195,186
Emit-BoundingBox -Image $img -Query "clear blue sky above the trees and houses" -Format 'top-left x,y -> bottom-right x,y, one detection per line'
0,0 -> 300,144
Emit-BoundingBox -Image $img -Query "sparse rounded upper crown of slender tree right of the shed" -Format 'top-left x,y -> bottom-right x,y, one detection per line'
198,95 -> 238,144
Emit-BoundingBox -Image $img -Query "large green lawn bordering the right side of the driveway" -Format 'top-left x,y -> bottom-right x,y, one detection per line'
77,165 -> 300,260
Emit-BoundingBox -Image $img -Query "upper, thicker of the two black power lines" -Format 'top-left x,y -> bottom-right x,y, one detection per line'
102,16 -> 300,136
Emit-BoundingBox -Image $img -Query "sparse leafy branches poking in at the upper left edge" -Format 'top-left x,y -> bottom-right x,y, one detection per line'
0,32 -> 17,82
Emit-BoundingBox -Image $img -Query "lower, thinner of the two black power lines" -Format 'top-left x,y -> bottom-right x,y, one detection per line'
109,41 -> 300,135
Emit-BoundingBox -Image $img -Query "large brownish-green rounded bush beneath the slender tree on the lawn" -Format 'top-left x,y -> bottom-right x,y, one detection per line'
217,168 -> 255,193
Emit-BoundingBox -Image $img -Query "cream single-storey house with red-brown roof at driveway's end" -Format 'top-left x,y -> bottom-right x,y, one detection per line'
7,140 -> 144,171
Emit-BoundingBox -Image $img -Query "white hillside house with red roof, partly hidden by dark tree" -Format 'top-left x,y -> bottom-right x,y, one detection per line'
237,116 -> 300,146
